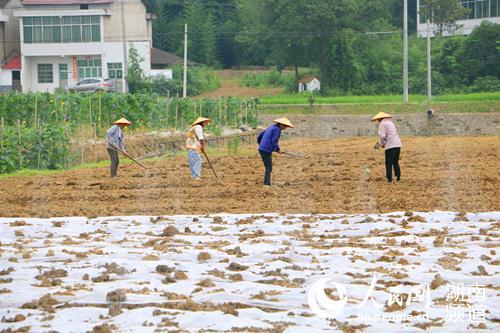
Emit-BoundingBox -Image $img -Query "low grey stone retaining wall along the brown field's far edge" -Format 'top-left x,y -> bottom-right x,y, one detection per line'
260,112 -> 500,138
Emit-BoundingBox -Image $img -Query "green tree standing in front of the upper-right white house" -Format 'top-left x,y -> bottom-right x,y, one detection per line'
420,0 -> 470,36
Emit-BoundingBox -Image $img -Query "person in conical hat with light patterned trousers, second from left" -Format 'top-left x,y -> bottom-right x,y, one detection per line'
186,117 -> 211,179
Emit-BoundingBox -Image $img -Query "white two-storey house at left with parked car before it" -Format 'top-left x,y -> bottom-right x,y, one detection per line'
0,0 -> 152,92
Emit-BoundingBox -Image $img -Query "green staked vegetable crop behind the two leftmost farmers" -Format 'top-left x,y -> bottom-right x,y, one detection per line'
0,93 -> 258,173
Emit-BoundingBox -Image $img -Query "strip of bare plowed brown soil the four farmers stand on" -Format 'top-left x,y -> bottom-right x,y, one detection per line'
0,137 -> 500,217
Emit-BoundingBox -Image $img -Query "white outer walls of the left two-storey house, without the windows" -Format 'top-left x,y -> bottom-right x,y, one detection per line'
12,0 -> 152,92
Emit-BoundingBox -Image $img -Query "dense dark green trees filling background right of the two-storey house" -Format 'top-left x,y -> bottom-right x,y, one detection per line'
150,0 -> 500,95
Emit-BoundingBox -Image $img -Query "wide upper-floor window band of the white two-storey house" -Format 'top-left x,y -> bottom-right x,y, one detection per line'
23,15 -> 101,44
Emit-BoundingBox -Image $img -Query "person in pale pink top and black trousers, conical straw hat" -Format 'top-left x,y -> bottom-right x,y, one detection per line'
372,112 -> 401,183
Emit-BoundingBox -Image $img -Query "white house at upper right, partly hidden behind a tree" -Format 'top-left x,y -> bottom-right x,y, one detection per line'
417,0 -> 500,37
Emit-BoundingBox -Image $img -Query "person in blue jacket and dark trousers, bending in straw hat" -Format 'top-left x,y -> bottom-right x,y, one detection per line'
257,118 -> 294,186
